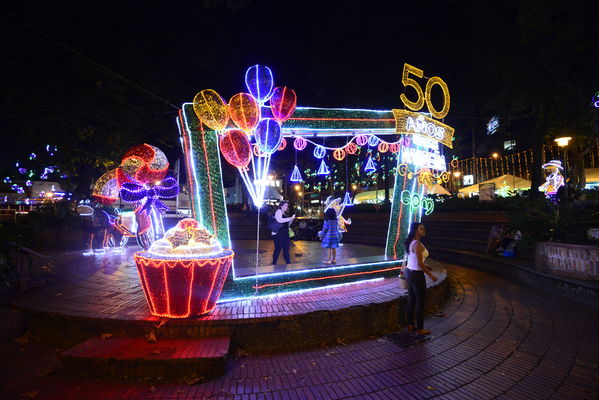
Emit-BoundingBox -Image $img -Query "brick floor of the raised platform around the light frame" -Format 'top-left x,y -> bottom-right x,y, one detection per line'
13,241 -> 432,323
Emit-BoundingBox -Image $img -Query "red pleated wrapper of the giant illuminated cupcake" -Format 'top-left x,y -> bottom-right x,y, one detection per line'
134,250 -> 234,318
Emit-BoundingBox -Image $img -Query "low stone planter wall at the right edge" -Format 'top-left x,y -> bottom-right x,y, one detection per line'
535,242 -> 599,281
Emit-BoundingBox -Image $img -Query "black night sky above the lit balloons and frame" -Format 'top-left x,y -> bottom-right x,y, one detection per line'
0,0 -> 599,188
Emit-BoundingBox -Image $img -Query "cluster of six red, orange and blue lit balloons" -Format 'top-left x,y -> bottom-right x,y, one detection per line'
193,65 -> 297,169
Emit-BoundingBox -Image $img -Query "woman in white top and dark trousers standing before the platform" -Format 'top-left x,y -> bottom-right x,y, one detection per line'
404,222 -> 437,335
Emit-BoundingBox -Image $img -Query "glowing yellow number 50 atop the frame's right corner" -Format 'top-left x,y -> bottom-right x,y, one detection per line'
399,64 -> 449,119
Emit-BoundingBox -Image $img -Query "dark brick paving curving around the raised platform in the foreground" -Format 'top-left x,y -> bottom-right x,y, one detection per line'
0,266 -> 599,400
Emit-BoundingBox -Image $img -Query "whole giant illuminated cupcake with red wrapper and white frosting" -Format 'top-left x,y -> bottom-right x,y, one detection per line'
134,218 -> 234,318
